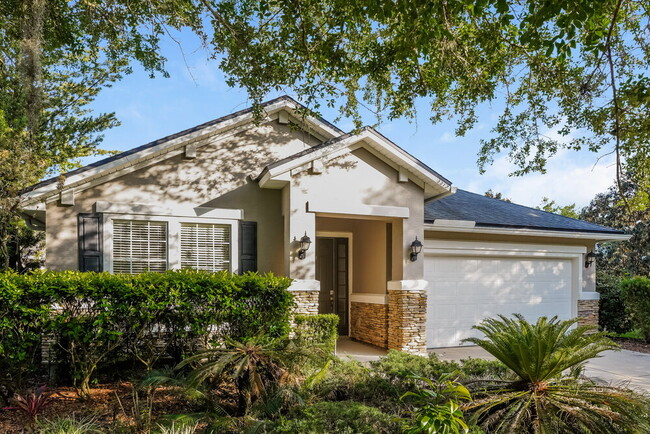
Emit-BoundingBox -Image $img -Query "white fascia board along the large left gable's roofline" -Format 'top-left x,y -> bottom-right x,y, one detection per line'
22,100 -> 340,205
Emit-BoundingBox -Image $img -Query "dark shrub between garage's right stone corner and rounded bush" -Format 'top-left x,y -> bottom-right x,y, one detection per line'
596,270 -> 632,333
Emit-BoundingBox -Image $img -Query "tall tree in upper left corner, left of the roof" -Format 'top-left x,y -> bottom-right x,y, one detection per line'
0,0 -> 200,268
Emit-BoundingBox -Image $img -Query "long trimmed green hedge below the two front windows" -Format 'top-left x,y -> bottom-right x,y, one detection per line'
0,270 -> 293,400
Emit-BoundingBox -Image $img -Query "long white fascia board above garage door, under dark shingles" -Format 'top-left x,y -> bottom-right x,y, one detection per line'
424,223 -> 632,242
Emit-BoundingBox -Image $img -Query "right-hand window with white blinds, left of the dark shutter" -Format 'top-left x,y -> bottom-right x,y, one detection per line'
181,223 -> 231,271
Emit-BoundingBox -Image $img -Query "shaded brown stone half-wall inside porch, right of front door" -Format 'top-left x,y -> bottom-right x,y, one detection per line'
350,301 -> 388,348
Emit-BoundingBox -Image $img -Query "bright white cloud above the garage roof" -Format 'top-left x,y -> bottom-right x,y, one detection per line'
467,150 -> 616,208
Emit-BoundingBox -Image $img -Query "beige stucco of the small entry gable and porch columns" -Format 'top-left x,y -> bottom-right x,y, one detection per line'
284,148 -> 424,282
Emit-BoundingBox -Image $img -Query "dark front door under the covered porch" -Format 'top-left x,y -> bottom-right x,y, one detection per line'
316,237 -> 349,336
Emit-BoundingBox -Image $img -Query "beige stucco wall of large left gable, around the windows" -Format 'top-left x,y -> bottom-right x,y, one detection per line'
46,122 -> 318,273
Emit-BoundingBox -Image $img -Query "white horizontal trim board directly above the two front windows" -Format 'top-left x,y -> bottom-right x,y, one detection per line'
95,201 -> 244,220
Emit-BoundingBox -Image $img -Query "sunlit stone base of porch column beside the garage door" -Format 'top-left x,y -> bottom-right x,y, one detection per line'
388,290 -> 427,354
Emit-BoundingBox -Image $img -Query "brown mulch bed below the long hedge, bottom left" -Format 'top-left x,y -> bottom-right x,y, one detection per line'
0,382 -> 193,433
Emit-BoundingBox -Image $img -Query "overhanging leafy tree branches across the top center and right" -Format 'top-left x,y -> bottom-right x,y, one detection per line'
199,0 -> 650,209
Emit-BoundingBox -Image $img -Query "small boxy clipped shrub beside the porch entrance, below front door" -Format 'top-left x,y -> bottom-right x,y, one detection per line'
293,314 -> 339,354
